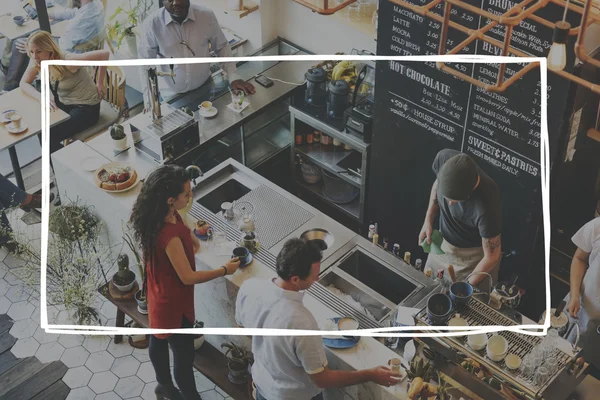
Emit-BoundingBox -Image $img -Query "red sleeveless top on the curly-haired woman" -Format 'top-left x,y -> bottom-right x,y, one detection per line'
146,212 -> 196,339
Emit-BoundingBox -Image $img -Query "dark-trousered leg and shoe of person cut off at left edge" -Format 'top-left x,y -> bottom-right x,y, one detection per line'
0,174 -> 54,253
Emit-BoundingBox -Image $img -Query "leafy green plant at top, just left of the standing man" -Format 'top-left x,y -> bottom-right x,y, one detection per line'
106,0 -> 154,58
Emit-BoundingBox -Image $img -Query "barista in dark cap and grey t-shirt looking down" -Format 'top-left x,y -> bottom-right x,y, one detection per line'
419,149 -> 502,290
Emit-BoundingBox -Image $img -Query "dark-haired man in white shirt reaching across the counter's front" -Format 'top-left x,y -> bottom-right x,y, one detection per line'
235,238 -> 399,400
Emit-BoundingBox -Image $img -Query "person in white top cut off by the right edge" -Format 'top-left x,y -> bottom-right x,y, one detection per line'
565,218 -> 600,373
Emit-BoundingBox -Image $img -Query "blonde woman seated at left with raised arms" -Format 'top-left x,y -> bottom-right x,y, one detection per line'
20,31 -> 110,153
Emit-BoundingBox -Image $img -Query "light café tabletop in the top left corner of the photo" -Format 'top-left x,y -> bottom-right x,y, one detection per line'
0,0 -> 69,41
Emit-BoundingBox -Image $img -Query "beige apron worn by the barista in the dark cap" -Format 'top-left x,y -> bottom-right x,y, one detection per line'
425,240 -> 500,293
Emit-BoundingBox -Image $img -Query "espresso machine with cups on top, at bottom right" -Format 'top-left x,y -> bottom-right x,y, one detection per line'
413,297 -> 589,400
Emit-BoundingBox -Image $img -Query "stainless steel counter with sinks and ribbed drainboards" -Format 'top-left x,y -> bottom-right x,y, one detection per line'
189,159 -> 437,328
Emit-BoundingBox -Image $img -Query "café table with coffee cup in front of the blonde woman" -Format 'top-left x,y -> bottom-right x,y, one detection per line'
0,88 -> 70,190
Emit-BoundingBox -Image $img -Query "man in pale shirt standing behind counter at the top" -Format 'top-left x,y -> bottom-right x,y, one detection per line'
138,0 -> 254,109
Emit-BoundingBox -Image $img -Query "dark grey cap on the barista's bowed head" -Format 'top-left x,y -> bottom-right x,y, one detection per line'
437,153 -> 479,201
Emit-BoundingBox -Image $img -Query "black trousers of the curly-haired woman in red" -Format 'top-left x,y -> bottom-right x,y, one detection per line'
148,317 -> 200,400
